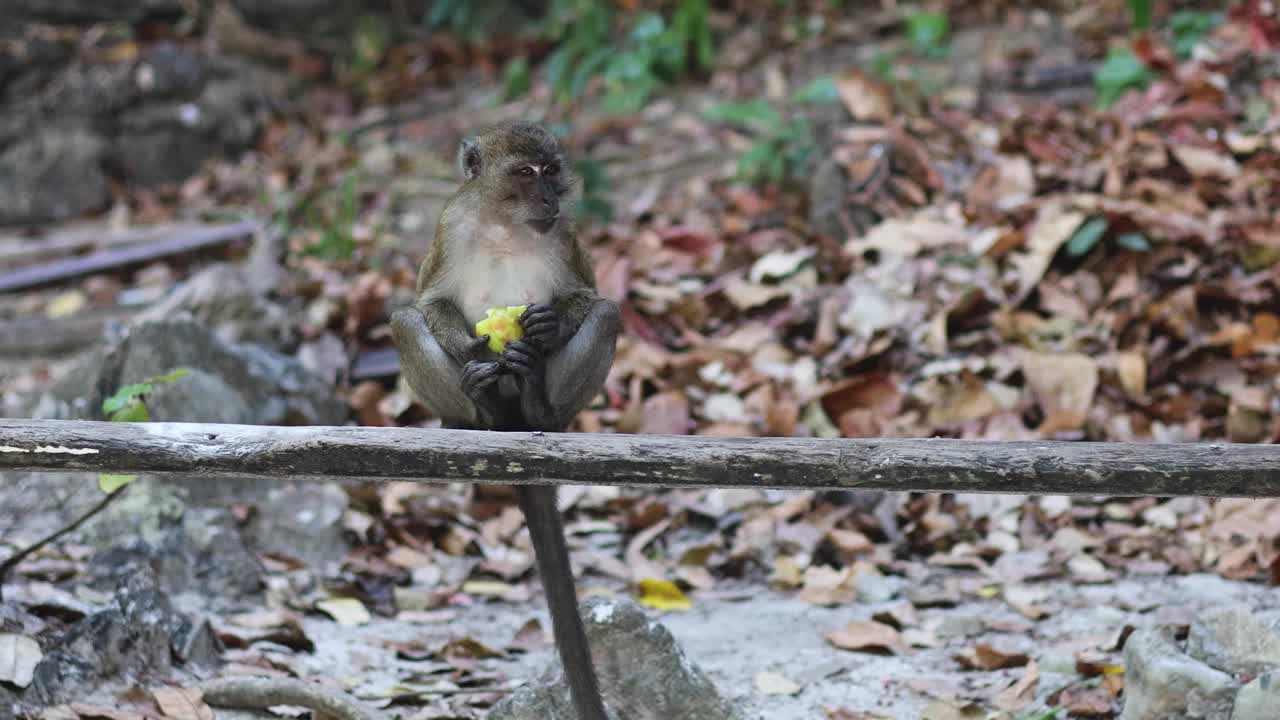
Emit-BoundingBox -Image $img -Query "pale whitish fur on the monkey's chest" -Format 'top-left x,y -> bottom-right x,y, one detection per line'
449,219 -> 566,323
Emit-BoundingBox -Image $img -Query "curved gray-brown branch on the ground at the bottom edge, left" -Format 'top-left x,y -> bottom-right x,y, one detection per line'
200,678 -> 383,720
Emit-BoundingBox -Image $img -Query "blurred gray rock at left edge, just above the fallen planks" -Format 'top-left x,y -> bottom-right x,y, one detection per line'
0,129 -> 110,225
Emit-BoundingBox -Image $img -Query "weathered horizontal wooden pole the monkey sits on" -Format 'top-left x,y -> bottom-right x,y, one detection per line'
0,419 -> 1280,497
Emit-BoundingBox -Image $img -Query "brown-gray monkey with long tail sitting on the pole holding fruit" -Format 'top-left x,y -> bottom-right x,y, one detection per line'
390,120 -> 622,720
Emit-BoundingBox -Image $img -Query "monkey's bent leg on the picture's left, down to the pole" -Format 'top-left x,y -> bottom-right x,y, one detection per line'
392,307 -> 500,428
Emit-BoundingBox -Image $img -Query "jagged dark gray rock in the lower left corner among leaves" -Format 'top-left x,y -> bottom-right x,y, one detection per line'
24,571 -> 220,705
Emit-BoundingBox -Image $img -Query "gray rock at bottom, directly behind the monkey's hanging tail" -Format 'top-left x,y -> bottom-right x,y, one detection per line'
489,598 -> 739,720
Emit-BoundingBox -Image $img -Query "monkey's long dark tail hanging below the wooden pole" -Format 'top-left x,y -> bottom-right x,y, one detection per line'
516,486 -> 608,720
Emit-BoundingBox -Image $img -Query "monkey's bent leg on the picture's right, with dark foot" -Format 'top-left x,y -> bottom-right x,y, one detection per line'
503,291 -> 622,432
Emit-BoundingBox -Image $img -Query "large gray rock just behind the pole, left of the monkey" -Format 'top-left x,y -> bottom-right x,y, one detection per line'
33,316 -> 347,425
